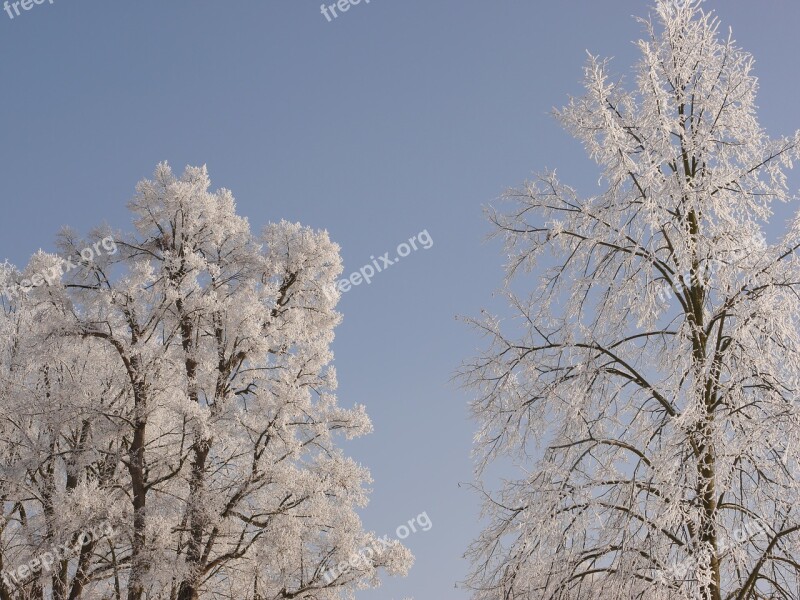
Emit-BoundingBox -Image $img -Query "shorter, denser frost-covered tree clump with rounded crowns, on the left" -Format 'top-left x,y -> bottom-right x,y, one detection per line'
0,164 -> 413,600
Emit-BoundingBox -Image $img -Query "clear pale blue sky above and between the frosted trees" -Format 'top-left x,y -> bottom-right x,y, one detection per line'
0,0 -> 800,600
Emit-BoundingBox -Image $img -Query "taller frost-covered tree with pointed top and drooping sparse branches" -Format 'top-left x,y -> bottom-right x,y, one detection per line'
460,0 -> 800,600
